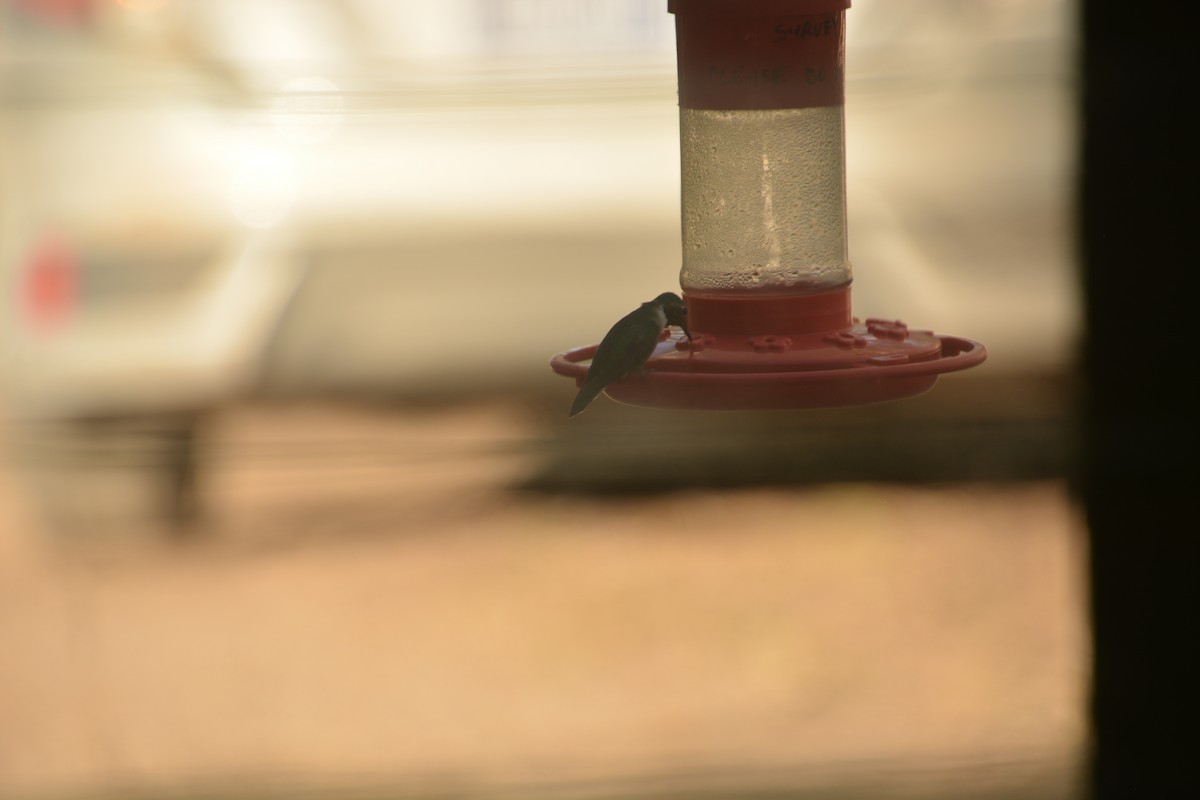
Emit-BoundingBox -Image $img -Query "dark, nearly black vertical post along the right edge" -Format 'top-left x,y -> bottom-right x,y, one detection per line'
1079,0 -> 1200,800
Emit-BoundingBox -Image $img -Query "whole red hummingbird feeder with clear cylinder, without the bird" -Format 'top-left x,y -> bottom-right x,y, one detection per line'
551,0 -> 986,409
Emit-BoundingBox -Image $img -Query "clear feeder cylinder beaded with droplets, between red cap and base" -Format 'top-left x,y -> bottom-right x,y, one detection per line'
679,106 -> 851,293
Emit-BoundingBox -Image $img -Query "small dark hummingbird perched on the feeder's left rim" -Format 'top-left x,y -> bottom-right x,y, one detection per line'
571,291 -> 691,416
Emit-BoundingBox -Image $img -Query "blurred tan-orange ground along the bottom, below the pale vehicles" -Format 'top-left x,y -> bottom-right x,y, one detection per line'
0,403 -> 1087,800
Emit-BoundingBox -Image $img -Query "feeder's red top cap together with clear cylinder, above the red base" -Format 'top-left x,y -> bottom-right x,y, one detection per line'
668,0 -> 851,293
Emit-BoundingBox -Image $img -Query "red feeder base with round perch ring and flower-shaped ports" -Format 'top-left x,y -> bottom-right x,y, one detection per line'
551,285 -> 988,410
